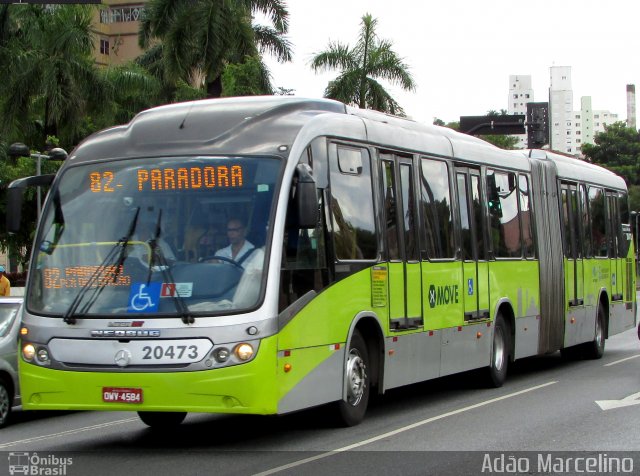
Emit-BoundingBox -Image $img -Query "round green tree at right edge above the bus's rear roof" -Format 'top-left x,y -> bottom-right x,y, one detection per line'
582,122 -> 640,186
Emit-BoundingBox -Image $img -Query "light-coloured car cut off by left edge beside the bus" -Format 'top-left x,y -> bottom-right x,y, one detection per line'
0,297 -> 23,428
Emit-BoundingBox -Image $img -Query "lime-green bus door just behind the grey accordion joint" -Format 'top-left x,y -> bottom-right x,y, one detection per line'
561,182 -> 585,345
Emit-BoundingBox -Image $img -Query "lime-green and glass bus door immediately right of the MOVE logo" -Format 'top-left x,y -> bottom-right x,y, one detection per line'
456,167 -> 490,322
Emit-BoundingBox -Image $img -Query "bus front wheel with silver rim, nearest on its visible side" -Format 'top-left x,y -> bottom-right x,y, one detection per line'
336,330 -> 371,426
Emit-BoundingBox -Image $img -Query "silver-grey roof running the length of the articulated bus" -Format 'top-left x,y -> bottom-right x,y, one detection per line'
68,96 -> 626,189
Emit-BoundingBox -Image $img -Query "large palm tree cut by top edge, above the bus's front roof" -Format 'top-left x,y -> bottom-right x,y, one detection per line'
139,0 -> 291,97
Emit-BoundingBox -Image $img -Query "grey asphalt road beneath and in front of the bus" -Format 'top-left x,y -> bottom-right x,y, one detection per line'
0,330 -> 640,476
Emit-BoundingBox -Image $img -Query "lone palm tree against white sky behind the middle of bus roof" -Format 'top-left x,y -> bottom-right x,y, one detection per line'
311,14 -> 415,115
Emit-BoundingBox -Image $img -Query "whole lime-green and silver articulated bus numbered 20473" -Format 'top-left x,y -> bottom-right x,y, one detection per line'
8,97 -> 636,426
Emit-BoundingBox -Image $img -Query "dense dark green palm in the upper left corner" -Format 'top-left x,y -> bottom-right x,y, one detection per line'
0,5 -> 107,147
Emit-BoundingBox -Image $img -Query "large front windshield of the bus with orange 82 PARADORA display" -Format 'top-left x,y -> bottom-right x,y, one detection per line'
27,157 -> 281,319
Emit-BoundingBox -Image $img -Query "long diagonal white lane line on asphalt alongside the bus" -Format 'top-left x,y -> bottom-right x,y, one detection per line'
253,381 -> 558,476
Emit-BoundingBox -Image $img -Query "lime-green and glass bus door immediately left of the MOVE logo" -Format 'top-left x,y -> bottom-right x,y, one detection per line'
380,154 -> 423,330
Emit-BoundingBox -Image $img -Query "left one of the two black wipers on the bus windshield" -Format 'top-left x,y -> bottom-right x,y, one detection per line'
62,207 -> 140,324
